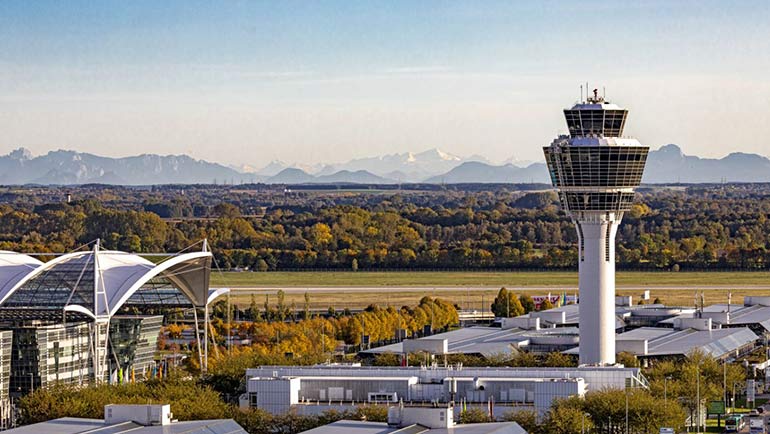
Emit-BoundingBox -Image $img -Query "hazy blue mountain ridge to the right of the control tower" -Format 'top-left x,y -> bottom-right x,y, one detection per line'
642,145 -> 770,184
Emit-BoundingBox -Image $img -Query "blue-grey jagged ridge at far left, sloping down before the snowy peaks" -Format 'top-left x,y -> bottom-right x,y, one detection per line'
0,148 -> 249,185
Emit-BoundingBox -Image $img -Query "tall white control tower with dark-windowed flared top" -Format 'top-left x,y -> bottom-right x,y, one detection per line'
543,90 -> 649,365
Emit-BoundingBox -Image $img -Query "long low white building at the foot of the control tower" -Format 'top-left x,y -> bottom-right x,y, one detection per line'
242,365 -> 647,416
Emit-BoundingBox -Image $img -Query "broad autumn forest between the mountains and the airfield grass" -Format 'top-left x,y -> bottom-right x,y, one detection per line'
0,184 -> 770,271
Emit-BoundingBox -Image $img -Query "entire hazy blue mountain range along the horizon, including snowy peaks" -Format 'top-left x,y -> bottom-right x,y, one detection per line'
0,144 -> 770,185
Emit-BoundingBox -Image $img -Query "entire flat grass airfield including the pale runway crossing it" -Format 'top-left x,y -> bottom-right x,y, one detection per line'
212,272 -> 770,310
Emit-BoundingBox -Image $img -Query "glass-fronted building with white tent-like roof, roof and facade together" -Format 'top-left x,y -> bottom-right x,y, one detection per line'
0,241 -> 226,427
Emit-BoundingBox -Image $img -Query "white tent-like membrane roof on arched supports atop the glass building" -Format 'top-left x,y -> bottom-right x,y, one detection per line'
0,242 -> 214,319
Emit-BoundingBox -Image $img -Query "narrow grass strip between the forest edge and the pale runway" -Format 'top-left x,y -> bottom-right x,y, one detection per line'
211,271 -> 770,288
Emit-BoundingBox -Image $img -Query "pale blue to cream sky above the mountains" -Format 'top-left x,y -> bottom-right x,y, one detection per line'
0,0 -> 770,167
